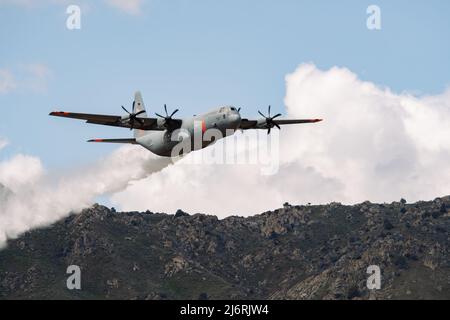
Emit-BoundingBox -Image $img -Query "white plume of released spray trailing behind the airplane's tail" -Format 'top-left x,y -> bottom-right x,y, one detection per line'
0,146 -> 171,247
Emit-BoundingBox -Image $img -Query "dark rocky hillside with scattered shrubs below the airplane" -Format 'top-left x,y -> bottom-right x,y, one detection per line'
0,197 -> 450,299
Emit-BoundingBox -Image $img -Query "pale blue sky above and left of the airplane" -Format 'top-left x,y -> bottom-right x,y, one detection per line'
0,0 -> 450,168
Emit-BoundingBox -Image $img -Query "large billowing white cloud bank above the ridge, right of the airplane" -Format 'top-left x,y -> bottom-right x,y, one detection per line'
112,64 -> 450,217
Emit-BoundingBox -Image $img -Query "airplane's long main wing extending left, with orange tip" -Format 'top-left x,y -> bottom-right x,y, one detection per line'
50,111 -> 163,131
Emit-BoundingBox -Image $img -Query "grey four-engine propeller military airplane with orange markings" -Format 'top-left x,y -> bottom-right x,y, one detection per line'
49,91 -> 322,157
